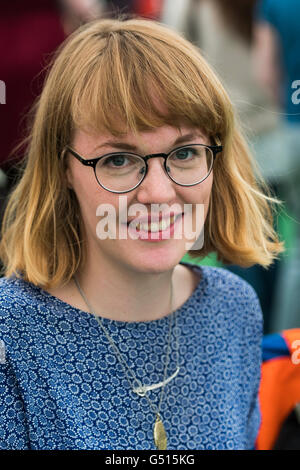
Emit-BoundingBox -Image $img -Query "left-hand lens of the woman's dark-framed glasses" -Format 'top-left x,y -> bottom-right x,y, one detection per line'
96,153 -> 146,191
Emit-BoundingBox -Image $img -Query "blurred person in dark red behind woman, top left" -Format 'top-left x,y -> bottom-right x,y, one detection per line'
0,0 -> 101,213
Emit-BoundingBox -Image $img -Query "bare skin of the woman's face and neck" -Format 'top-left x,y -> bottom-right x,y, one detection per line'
48,125 -> 213,321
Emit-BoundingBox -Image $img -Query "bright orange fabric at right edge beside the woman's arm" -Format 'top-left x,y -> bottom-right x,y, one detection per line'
256,329 -> 300,450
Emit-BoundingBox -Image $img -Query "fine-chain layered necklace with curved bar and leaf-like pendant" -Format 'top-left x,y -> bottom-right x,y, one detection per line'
74,276 -> 180,450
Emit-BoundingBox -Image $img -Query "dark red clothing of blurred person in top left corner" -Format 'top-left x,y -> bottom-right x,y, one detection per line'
0,0 -> 65,187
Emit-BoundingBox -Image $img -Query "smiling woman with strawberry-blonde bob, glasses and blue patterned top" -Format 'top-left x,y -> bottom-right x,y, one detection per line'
0,19 -> 283,449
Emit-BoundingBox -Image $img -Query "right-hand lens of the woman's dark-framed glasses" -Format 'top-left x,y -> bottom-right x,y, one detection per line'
167,145 -> 214,184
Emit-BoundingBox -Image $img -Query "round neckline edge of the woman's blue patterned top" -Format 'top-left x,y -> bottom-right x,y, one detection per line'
17,261 -> 204,326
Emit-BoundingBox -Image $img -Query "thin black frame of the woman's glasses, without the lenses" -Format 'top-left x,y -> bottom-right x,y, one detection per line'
64,144 -> 223,194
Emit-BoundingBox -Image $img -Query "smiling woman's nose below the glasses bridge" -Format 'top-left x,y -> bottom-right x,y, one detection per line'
137,157 -> 176,204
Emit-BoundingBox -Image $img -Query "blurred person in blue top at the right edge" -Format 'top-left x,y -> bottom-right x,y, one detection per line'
254,0 -> 300,332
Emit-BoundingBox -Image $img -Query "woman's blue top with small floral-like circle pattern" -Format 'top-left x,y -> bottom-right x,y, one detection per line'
0,263 -> 262,450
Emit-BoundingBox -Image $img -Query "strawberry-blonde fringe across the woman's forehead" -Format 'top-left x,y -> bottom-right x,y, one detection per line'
71,26 -> 228,136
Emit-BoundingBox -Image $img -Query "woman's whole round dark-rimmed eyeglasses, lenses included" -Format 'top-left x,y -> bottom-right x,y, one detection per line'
65,144 -> 223,194
